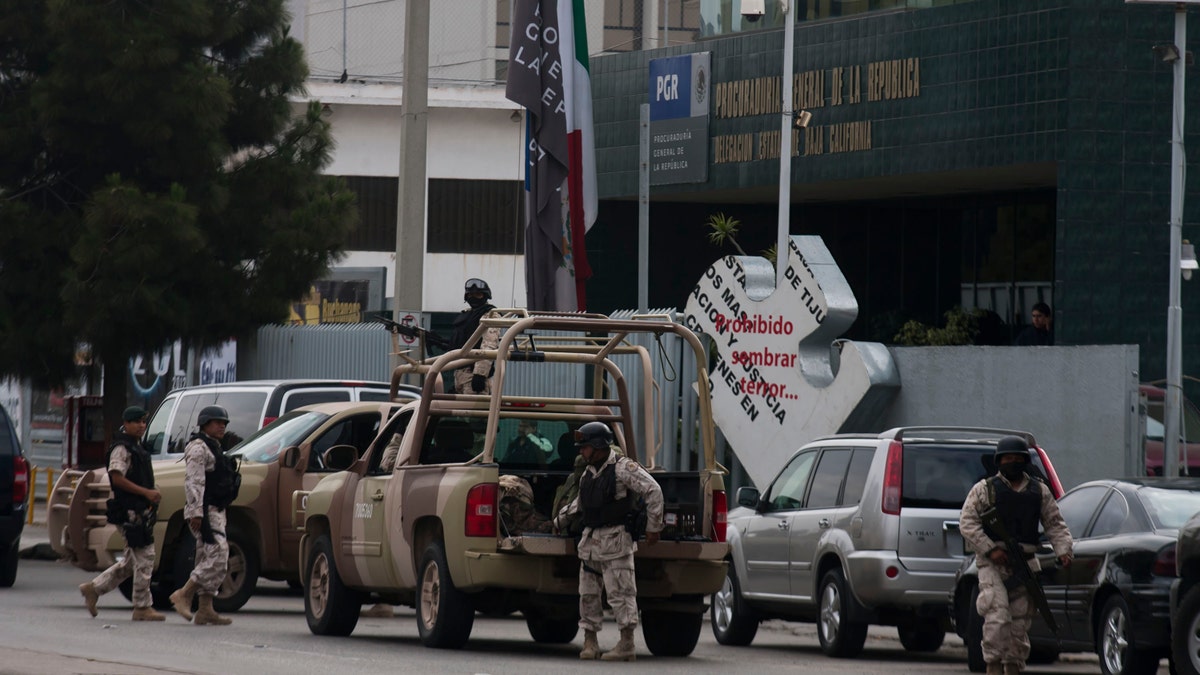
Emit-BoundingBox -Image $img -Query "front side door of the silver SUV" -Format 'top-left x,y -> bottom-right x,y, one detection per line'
738,448 -> 818,598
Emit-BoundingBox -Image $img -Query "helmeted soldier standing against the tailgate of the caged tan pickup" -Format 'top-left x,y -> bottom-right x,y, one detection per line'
554,422 -> 662,661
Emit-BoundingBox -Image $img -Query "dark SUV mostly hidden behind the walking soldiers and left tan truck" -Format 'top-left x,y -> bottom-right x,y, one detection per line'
145,380 -> 421,460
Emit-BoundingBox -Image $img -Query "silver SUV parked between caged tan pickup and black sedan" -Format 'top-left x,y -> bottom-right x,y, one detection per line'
712,426 -> 1062,657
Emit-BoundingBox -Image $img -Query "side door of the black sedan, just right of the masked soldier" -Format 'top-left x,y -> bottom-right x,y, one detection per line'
1056,485 -> 1110,644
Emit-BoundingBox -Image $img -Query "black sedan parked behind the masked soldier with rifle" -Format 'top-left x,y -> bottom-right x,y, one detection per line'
952,478 -> 1200,675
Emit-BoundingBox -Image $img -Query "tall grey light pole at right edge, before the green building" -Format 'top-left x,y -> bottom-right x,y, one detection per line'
1163,4 -> 1188,476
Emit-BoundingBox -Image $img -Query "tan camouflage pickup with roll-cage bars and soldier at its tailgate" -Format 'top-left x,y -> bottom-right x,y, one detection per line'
300,310 -> 728,656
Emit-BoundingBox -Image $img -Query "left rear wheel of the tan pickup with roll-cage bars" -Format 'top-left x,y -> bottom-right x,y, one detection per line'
416,542 -> 475,649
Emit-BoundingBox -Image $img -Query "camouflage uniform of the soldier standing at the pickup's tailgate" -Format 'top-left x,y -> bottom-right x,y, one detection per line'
554,448 -> 662,632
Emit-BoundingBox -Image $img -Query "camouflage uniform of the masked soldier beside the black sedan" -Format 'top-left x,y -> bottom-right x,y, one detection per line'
959,476 -> 1072,670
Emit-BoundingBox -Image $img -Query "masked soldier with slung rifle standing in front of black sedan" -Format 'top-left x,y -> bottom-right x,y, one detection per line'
959,436 -> 1073,675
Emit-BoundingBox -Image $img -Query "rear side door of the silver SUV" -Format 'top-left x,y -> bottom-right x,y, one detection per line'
788,448 -> 862,602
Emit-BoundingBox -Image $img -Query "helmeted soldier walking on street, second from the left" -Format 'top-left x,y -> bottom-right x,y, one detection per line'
170,406 -> 241,626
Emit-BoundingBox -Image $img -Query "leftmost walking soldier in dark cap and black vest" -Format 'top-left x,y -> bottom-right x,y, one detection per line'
79,406 -> 166,621
